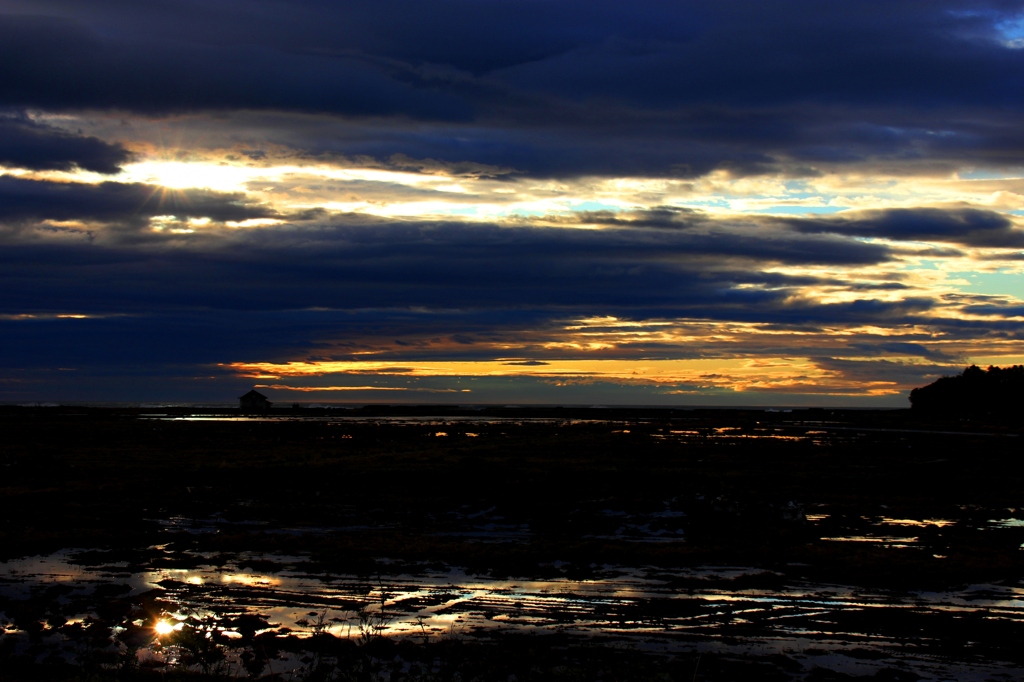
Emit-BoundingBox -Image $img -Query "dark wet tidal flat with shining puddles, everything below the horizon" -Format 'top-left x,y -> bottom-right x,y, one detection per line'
0,407 -> 1024,682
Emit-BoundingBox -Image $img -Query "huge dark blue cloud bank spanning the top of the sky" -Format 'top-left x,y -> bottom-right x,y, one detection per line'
0,0 -> 1024,176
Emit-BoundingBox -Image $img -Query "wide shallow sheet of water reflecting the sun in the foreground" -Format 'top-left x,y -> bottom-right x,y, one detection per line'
0,550 -> 1024,679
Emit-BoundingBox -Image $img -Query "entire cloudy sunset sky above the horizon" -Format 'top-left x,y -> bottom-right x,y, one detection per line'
0,0 -> 1024,408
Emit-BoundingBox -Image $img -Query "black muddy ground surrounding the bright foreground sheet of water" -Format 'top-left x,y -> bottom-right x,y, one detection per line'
0,408 -> 1024,682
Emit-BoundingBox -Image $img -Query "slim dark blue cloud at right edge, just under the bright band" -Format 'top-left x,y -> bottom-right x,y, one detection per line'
785,207 -> 1024,249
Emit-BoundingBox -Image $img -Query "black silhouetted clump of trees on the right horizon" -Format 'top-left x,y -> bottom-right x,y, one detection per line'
910,365 -> 1024,416
